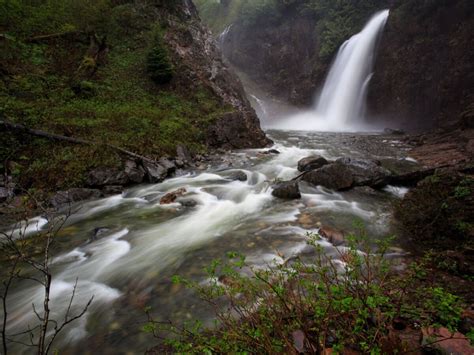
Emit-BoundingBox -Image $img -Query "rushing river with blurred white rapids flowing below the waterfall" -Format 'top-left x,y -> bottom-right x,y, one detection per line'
1,131 -> 414,354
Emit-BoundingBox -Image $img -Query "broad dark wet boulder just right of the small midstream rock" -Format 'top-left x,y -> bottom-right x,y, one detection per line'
302,163 -> 354,190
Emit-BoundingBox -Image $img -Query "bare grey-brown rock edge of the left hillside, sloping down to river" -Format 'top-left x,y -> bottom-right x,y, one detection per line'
165,0 -> 270,148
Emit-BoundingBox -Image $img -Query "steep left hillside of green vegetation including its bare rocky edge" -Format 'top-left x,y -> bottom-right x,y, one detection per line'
0,0 -> 270,190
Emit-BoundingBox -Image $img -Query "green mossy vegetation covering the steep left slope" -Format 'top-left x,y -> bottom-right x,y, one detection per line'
0,0 -> 230,190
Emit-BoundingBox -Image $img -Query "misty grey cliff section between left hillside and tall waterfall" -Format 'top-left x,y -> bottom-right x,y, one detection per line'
220,11 -> 318,105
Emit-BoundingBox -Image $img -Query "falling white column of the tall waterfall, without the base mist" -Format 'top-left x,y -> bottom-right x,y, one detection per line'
316,10 -> 389,126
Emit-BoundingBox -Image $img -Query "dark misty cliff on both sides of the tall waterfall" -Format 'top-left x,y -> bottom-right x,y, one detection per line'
202,0 -> 474,129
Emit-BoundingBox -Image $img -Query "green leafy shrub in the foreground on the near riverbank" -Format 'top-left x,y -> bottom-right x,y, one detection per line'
146,231 -> 460,354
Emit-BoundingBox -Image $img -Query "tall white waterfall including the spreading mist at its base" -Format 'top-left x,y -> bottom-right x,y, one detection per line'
275,10 -> 389,131
